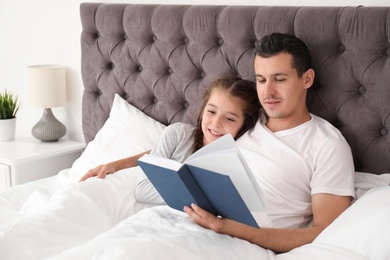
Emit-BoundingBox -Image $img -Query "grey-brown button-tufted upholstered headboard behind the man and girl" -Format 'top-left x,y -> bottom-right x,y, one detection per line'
80,3 -> 390,174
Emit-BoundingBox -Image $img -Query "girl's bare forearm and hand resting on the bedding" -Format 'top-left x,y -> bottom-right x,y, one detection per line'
80,150 -> 150,181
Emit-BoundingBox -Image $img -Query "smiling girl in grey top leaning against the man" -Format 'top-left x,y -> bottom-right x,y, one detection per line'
80,77 -> 260,204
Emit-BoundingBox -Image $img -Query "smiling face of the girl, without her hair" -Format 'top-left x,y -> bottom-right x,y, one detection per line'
202,88 -> 244,145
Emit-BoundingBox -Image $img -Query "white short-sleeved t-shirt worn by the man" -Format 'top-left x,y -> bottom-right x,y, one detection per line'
237,114 -> 354,228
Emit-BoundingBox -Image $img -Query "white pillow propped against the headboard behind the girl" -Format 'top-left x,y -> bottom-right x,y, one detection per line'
58,94 -> 165,184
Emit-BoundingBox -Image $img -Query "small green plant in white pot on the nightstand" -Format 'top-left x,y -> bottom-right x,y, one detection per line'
0,90 -> 20,141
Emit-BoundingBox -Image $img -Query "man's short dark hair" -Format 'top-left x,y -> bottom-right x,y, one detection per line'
255,32 -> 311,77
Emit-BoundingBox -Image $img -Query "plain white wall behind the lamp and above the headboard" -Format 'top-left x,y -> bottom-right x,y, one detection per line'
0,0 -> 390,141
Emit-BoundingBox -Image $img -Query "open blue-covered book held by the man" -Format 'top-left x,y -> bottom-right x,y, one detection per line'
138,134 -> 264,227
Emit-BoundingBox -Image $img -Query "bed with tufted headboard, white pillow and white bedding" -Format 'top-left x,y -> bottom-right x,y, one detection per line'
0,3 -> 390,260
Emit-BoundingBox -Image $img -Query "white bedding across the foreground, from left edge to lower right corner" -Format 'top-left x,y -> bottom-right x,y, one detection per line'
0,168 -> 390,260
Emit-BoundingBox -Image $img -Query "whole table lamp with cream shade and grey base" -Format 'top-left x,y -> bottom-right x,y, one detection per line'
27,65 -> 66,142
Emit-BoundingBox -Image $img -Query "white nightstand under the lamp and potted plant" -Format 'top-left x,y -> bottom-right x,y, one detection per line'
0,138 -> 85,190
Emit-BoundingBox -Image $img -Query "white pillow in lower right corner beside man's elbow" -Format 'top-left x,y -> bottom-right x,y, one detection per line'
313,186 -> 390,259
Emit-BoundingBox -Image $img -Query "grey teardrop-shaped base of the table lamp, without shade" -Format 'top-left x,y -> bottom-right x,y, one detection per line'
31,108 -> 66,142
